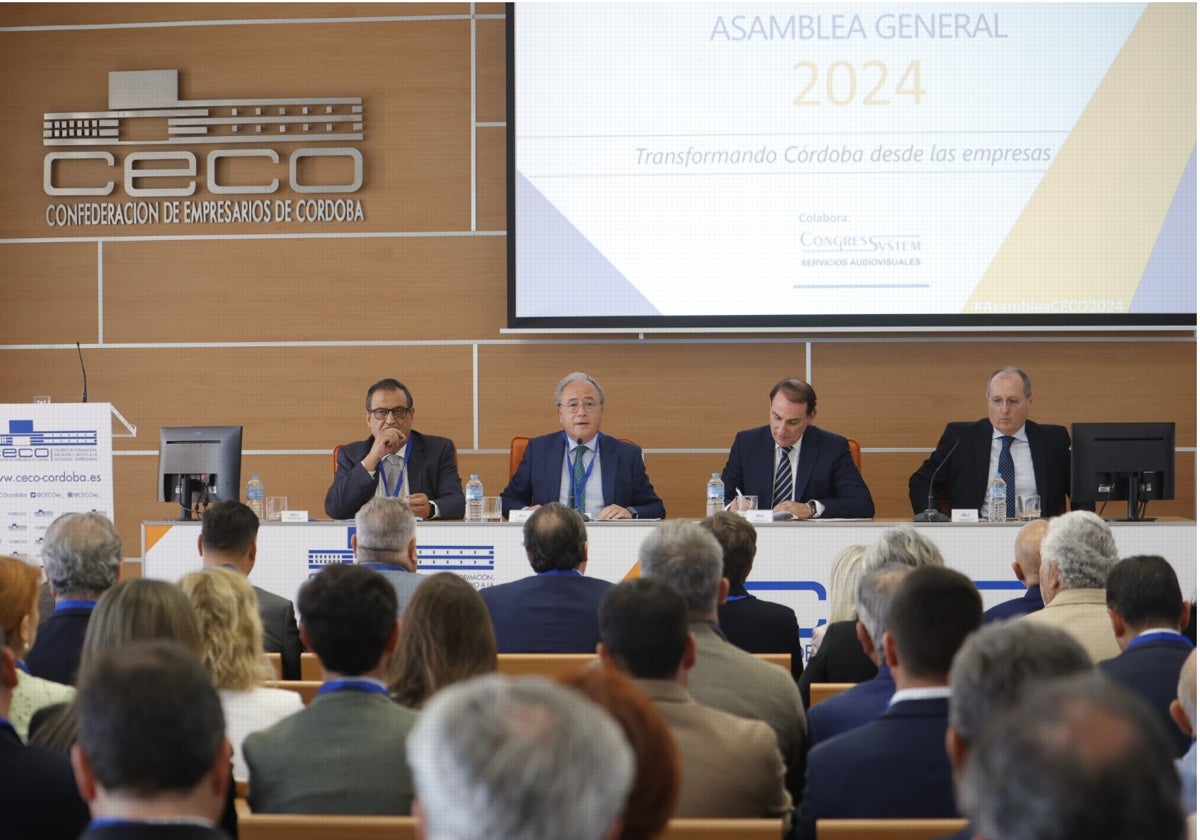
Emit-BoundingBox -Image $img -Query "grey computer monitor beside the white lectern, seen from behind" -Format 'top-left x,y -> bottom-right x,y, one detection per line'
158,426 -> 241,520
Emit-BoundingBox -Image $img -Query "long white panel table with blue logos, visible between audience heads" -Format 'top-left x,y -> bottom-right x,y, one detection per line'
142,520 -> 1196,638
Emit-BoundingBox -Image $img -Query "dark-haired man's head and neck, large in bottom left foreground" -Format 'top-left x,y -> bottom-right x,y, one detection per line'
71,641 -> 232,840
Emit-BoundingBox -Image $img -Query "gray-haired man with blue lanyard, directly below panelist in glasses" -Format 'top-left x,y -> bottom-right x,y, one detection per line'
350,496 -> 425,618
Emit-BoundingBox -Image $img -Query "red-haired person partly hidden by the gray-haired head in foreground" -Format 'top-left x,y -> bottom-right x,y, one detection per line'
559,667 -> 681,840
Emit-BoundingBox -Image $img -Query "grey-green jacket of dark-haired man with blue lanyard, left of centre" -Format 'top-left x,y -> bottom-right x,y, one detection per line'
242,691 -> 418,815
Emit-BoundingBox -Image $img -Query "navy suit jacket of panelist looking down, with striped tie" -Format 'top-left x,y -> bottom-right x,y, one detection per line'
721,426 -> 875,520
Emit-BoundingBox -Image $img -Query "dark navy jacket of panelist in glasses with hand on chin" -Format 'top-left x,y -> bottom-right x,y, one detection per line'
325,432 -> 467,520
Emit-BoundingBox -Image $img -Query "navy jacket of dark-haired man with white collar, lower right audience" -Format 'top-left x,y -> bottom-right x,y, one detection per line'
797,696 -> 959,840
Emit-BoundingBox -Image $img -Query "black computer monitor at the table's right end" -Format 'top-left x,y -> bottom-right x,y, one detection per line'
1070,422 -> 1175,522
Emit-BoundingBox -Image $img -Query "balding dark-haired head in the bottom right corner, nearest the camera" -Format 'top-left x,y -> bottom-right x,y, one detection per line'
959,672 -> 1184,840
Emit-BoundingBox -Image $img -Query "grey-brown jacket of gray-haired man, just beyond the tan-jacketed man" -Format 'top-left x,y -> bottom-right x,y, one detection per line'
688,622 -> 808,798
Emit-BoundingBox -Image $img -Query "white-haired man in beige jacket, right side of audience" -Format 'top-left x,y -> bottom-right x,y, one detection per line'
1019,510 -> 1121,664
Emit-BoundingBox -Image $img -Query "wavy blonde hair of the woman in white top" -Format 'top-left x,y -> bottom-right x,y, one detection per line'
179,566 -> 275,691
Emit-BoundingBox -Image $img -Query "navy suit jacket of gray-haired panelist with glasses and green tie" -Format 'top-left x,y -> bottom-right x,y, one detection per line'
500,432 -> 667,520
